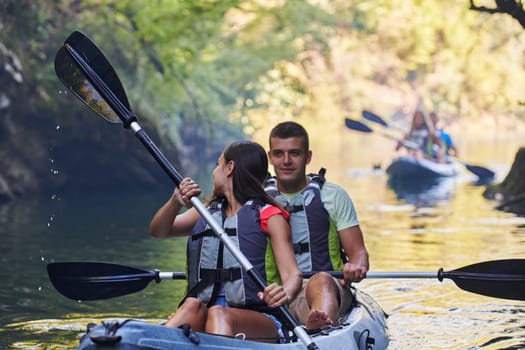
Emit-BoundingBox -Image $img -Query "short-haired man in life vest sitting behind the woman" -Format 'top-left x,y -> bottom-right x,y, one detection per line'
266,121 -> 369,329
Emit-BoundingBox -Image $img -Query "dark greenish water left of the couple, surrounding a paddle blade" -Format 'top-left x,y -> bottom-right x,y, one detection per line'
0,193 -> 185,349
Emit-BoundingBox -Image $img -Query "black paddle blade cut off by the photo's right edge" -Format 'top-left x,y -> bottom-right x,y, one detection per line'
438,259 -> 525,300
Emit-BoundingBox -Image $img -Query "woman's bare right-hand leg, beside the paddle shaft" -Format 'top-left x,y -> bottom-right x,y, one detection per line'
206,305 -> 278,343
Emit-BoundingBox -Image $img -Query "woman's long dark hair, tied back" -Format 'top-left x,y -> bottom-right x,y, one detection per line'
223,141 -> 278,206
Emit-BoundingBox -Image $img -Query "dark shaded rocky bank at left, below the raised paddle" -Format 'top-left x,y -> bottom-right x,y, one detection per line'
0,42 -> 178,203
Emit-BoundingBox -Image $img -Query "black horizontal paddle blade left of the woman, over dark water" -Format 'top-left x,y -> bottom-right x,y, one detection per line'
47,262 -> 156,300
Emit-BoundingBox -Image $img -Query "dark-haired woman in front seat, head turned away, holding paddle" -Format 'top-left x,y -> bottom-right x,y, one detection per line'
150,141 -> 302,342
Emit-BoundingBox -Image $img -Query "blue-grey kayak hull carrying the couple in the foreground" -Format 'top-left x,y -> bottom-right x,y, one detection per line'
77,291 -> 390,350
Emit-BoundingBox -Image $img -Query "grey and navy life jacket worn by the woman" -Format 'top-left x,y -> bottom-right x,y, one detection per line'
186,200 -> 275,309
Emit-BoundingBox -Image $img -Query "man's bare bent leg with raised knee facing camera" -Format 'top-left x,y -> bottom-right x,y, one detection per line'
306,272 -> 341,329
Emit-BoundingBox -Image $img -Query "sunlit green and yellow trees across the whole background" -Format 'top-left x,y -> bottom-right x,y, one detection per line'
0,0 -> 525,178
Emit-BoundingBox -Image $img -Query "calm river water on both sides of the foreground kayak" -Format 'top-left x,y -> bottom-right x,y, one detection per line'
0,122 -> 525,349
